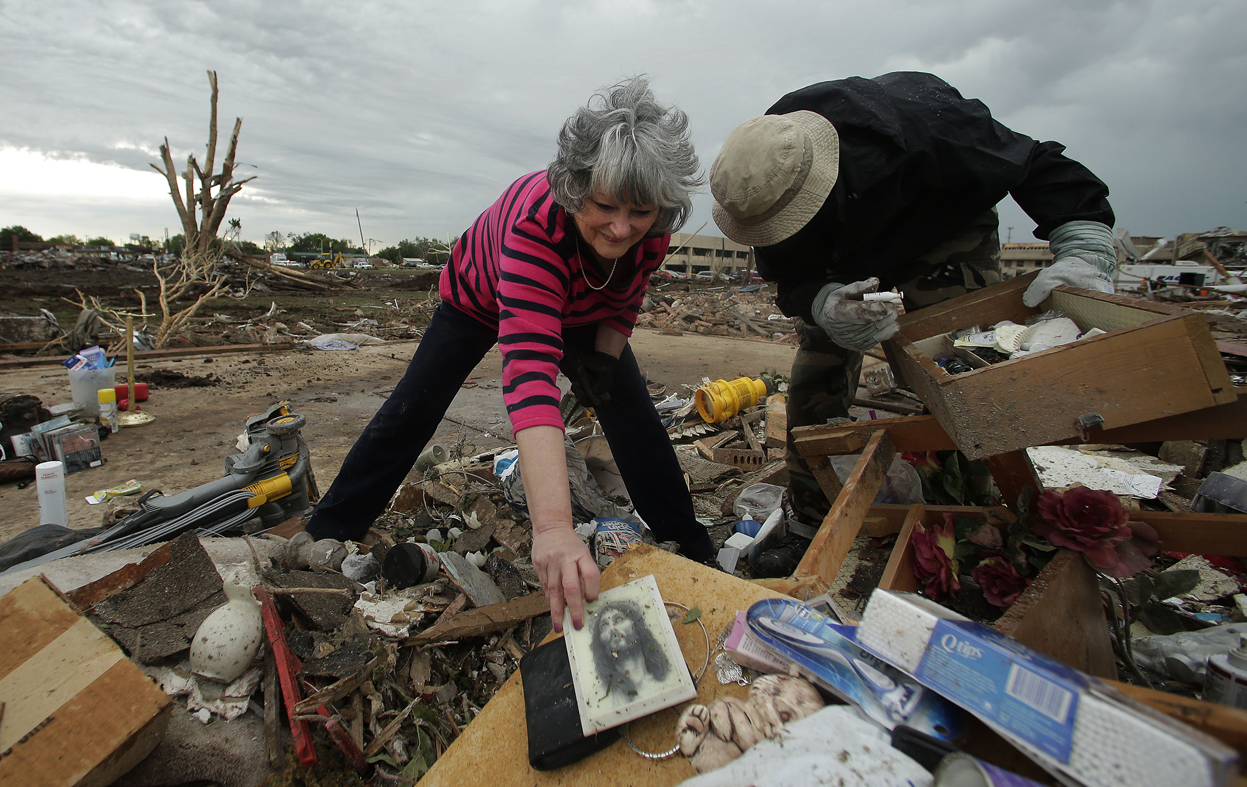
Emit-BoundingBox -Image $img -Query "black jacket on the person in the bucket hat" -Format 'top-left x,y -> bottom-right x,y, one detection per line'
757,71 -> 1114,322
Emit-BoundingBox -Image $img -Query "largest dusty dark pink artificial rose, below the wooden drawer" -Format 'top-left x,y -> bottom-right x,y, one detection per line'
1035,486 -> 1130,569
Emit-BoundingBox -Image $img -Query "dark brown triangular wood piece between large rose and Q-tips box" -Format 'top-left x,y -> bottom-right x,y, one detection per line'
994,549 -> 1117,678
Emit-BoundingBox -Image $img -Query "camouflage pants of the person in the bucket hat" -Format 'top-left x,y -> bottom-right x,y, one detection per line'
786,208 -> 1003,526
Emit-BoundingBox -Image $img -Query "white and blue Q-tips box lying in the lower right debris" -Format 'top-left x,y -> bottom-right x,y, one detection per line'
857,589 -> 1237,787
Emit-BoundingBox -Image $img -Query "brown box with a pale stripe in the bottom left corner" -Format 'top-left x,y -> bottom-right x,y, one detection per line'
0,576 -> 172,787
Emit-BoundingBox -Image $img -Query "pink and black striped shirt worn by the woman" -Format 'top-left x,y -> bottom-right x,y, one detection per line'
439,172 -> 671,432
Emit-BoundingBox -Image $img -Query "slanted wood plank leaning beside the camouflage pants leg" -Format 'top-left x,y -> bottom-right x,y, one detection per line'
793,429 -> 897,585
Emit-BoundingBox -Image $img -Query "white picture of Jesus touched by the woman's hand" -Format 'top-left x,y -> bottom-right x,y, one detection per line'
562,574 -> 697,737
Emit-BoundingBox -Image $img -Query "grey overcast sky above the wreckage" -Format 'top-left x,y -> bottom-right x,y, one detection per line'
0,0 -> 1247,251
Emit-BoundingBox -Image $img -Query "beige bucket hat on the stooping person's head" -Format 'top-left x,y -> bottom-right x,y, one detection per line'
710,110 -> 840,246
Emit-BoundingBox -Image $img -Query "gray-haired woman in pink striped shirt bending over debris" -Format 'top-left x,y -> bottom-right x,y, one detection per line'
307,77 -> 715,631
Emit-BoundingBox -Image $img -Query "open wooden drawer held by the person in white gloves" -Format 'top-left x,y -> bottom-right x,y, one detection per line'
884,274 -> 1236,459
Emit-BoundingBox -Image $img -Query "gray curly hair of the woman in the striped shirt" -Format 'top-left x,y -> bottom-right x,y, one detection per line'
546,76 -> 706,236
